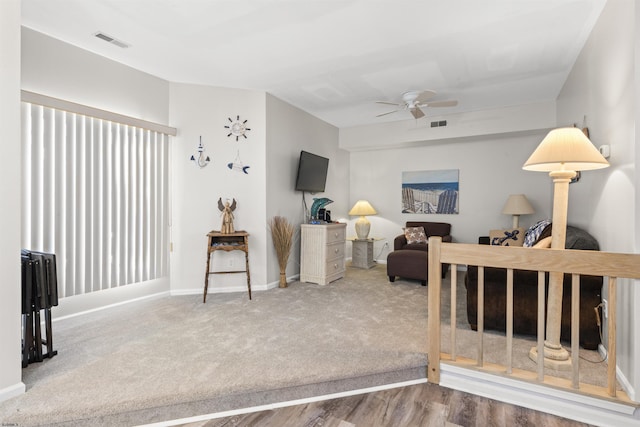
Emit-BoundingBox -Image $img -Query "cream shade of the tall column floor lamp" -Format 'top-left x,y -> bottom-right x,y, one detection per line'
522,127 -> 609,172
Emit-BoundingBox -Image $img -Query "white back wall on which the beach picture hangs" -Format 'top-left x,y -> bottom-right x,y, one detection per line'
350,132 -> 551,259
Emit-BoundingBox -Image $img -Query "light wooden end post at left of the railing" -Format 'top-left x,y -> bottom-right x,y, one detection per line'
427,236 -> 442,384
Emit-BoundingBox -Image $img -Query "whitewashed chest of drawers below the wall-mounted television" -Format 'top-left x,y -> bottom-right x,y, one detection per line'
300,224 -> 347,285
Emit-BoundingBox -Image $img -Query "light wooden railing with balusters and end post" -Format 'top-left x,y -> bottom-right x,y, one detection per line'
427,237 -> 640,405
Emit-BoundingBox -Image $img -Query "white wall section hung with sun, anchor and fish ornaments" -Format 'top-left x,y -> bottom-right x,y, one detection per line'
170,83 -> 267,294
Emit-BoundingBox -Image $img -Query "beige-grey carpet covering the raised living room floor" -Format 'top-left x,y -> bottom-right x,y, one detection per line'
0,265 -> 606,426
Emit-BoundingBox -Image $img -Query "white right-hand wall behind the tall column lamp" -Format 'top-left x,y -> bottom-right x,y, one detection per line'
557,0 -> 640,398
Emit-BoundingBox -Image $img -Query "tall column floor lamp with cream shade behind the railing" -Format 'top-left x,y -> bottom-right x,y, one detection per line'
522,128 -> 609,370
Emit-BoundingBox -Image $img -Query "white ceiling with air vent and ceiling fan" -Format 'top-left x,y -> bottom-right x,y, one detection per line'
22,0 -> 606,127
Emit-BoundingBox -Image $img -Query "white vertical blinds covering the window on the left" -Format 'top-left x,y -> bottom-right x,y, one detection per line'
22,102 -> 169,297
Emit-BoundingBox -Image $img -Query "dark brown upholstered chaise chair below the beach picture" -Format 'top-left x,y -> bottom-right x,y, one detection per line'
387,221 -> 452,286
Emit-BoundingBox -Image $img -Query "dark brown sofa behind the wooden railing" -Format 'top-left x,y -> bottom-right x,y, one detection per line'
465,225 -> 602,350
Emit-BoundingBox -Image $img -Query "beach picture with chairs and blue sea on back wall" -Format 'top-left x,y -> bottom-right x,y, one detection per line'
402,169 -> 459,214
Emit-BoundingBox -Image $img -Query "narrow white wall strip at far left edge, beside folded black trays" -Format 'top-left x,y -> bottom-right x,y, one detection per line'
0,0 -> 25,401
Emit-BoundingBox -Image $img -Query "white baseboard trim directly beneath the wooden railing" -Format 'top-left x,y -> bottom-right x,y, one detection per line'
440,364 -> 640,427
